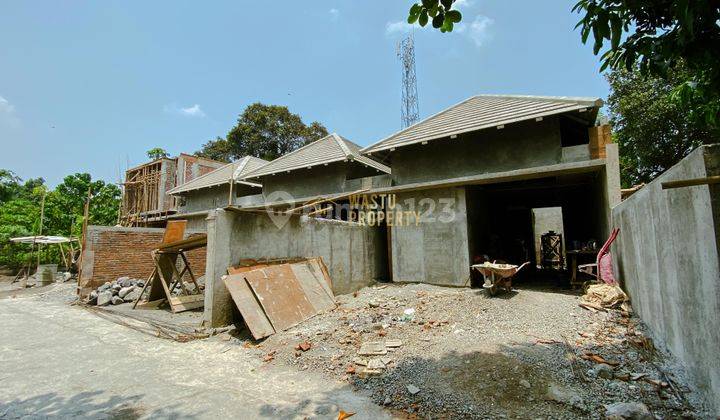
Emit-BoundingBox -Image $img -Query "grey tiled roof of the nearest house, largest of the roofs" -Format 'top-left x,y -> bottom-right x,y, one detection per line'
361,95 -> 603,153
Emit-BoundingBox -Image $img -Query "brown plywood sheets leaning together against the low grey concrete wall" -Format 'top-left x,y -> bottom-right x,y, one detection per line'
223,258 -> 336,340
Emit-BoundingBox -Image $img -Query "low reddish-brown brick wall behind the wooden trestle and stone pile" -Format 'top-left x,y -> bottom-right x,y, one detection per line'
78,226 -> 205,296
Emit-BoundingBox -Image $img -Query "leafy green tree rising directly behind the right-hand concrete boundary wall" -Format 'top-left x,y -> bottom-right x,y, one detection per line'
607,67 -> 717,188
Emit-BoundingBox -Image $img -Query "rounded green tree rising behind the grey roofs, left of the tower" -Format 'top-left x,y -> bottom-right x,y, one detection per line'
197,103 -> 328,161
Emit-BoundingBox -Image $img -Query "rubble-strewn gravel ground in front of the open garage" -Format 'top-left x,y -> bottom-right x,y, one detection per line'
238,284 -> 706,418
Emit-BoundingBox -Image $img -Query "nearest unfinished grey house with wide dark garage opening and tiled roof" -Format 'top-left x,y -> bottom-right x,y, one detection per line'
362,95 -> 620,286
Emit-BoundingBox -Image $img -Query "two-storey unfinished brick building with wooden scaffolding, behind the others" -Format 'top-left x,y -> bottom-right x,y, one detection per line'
120,154 -> 226,227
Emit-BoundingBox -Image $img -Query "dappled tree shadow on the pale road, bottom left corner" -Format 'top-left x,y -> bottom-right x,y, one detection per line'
0,391 -> 195,420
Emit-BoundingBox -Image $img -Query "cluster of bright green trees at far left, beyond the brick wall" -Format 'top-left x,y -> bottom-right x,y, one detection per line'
0,170 -> 120,268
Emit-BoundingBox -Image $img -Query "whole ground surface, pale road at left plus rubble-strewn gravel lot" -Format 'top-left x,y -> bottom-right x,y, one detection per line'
0,278 -> 711,418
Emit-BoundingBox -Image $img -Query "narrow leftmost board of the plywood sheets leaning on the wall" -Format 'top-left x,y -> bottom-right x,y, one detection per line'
223,274 -> 275,340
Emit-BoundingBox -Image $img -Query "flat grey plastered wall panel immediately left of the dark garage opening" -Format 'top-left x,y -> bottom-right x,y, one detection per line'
391,187 -> 470,286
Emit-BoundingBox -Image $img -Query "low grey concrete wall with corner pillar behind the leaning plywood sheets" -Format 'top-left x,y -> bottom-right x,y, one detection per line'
205,210 -> 387,326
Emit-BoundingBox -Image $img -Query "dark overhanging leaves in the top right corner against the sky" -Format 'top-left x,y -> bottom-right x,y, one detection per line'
573,0 -> 720,127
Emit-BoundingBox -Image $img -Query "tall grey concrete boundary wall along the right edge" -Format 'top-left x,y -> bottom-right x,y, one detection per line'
612,145 -> 720,414
